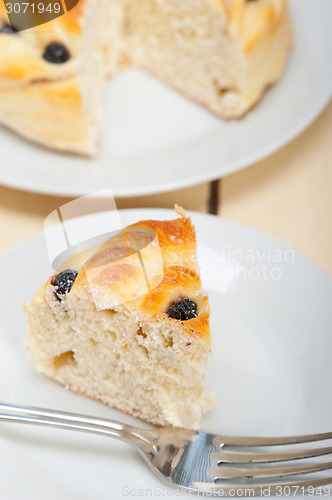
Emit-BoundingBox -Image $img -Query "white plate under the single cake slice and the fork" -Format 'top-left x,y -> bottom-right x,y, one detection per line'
0,209 -> 332,500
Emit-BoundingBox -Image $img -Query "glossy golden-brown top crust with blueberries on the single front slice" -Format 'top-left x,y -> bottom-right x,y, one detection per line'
35,207 -> 210,347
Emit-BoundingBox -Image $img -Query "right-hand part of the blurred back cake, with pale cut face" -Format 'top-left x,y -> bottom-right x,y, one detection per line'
122,0 -> 292,119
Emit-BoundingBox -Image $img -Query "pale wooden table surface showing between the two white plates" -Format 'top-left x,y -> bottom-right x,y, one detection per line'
0,98 -> 332,274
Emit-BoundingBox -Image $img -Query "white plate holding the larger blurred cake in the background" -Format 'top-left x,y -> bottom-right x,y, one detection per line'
0,0 -> 332,197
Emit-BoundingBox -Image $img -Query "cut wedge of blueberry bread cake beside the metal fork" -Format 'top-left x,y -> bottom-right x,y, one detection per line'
23,208 -> 211,428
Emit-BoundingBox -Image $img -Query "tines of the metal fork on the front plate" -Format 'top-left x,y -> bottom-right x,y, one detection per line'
209,433 -> 332,495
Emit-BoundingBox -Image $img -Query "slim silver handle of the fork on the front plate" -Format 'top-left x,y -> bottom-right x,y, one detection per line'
0,403 -> 156,453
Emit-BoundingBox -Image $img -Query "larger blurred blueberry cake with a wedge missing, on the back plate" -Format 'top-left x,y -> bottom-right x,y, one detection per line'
0,0 -> 291,155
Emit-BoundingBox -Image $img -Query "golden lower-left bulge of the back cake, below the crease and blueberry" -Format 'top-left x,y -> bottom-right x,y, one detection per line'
0,76 -> 96,155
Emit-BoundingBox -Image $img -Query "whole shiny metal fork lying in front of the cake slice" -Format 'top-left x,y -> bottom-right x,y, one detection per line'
0,403 -> 332,496
